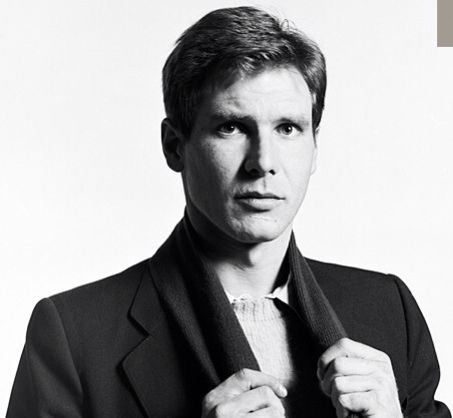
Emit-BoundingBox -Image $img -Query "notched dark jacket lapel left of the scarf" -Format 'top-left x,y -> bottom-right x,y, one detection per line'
122,233 -> 217,417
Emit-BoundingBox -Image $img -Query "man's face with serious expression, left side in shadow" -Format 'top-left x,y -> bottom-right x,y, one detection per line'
182,67 -> 316,243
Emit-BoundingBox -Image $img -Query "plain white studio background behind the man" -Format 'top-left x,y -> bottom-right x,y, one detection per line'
0,0 -> 453,415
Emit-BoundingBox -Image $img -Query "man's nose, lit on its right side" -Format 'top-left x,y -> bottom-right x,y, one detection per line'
244,133 -> 278,177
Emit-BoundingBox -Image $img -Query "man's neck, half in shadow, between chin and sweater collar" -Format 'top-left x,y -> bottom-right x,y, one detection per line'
185,208 -> 291,298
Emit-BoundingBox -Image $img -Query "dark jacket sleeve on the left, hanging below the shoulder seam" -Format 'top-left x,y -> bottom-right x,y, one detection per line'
6,299 -> 83,418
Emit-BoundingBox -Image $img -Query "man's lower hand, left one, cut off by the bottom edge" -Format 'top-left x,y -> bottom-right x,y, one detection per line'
202,369 -> 286,418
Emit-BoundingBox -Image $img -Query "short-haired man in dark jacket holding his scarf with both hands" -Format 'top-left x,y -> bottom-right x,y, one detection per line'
7,7 -> 450,418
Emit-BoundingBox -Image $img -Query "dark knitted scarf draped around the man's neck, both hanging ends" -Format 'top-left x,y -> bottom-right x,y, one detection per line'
154,219 -> 358,418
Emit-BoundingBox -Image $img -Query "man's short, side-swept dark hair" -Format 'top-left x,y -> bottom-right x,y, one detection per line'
162,7 -> 327,135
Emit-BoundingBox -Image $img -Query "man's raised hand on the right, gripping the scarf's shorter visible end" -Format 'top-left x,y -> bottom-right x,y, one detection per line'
317,338 -> 403,418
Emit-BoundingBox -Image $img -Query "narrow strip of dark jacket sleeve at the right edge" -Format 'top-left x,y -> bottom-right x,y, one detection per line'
393,276 -> 451,418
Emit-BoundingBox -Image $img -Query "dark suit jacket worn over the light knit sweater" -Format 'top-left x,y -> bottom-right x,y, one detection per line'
7,230 -> 451,418
